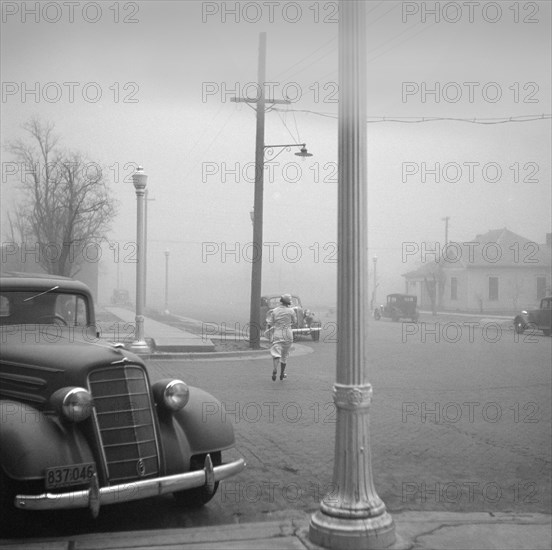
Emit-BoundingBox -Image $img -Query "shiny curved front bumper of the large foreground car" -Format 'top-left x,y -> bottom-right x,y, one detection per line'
14,455 -> 245,517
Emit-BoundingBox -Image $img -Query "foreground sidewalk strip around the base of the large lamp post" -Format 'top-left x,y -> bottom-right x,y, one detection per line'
0,512 -> 552,550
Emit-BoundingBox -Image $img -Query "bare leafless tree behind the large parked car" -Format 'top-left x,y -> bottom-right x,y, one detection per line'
6,118 -> 116,276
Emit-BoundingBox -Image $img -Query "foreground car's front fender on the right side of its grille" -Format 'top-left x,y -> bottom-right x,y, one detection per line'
159,387 -> 235,474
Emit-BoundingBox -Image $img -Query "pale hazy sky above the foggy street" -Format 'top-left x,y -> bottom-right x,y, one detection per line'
1,0 -> 552,319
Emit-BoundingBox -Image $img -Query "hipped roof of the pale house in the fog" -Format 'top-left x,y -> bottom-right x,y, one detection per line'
403,228 -> 552,279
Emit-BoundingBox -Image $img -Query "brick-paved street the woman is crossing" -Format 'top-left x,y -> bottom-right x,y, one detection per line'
15,320 -> 552,536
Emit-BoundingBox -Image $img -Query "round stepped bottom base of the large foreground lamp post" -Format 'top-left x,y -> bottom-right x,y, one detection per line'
309,511 -> 395,550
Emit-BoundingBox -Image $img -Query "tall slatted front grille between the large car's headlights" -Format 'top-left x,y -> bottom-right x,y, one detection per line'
88,365 -> 159,484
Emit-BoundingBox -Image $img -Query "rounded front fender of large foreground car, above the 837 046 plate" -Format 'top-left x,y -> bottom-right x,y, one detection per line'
0,400 -> 95,480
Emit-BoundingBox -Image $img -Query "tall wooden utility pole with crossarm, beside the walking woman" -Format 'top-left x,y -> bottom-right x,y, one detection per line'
231,32 -> 289,349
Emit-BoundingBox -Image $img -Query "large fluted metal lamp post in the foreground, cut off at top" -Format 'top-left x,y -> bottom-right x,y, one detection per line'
309,0 -> 395,550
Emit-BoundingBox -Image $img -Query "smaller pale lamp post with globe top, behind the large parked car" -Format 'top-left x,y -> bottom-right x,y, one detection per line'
130,166 -> 150,353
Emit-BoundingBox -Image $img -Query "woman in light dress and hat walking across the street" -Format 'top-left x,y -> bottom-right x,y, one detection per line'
266,294 -> 297,380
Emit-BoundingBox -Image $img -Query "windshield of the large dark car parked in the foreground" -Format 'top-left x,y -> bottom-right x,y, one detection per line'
0,290 -> 89,326
